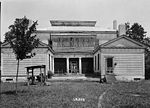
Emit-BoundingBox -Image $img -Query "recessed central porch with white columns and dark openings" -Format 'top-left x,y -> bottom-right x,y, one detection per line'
54,57 -> 94,77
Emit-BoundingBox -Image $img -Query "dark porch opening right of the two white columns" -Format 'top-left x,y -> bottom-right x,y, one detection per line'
82,58 -> 93,75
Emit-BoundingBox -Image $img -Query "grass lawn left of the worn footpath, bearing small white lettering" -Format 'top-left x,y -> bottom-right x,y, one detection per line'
0,81 -> 110,108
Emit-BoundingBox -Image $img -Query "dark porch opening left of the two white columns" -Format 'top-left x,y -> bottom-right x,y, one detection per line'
54,58 -> 67,74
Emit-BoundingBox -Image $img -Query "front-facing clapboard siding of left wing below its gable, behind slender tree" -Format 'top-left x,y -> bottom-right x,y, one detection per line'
2,54 -> 47,76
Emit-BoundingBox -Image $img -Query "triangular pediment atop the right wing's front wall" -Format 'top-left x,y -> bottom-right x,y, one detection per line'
101,36 -> 145,48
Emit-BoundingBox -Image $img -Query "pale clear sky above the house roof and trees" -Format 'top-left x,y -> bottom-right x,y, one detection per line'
1,0 -> 150,41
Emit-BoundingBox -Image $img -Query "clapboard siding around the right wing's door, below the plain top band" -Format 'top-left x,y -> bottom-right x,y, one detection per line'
101,54 -> 144,77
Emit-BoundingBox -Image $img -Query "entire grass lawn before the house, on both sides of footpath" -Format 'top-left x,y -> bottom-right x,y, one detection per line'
0,81 -> 150,108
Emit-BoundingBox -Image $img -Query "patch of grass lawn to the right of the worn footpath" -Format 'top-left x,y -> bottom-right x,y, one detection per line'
102,81 -> 150,108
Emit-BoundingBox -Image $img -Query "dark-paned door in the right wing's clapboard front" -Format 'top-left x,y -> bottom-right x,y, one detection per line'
106,57 -> 113,73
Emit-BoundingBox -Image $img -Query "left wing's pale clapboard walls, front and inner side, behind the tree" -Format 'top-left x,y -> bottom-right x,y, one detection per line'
1,48 -> 53,76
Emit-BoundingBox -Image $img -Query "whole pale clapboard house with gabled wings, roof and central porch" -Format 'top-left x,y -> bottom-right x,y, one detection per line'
2,20 -> 145,80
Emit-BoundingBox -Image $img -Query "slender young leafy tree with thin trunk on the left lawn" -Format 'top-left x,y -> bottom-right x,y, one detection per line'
5,17 -> 39,93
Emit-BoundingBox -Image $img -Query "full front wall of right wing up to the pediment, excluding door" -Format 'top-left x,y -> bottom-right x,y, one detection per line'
101,49 -> 145,80
